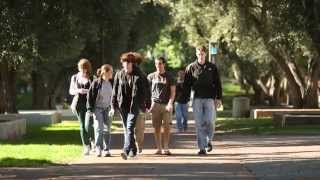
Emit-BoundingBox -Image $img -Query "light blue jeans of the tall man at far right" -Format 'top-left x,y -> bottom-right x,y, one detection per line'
193,98 -> 216,150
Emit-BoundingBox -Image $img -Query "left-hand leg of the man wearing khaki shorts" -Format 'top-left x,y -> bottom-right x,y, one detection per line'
151,103 -> 162,154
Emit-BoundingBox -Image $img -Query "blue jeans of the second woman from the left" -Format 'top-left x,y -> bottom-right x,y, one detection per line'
94,108 -> 112,150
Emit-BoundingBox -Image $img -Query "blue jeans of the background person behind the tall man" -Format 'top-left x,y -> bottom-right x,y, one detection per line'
175,103 -> 188,131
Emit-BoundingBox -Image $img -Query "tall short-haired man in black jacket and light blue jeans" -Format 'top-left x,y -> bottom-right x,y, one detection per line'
183,46 -> 222,155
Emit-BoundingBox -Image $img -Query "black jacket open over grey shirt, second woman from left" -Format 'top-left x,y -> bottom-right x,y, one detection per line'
87,77 -> 113,112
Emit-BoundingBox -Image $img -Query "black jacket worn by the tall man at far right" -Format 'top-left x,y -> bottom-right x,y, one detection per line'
183,61 -> 222,100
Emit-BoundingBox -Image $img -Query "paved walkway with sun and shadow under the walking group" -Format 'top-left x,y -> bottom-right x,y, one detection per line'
0,121 -> 320,179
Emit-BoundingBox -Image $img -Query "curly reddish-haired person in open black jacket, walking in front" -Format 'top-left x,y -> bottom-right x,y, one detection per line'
112,52 -> 151,159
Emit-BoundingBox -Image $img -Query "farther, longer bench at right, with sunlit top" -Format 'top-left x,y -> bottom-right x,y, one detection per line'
250,108 -> 320,119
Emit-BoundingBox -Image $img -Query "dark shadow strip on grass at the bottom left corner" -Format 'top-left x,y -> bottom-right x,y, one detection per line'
0,157 -> 57,167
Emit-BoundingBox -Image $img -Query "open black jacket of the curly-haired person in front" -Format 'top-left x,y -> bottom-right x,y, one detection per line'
111,65 -> 151,113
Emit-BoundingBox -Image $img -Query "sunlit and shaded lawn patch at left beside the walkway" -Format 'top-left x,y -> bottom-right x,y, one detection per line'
0,122 -> 82,167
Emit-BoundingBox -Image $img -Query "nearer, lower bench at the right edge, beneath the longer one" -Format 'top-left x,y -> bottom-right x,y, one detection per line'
272,112 -> 320,128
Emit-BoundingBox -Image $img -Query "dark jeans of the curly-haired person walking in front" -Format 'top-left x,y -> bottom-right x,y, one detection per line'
120,108 -> 138,155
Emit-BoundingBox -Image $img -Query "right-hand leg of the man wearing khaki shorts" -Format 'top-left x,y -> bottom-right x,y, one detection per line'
163,106 -> 172,155
